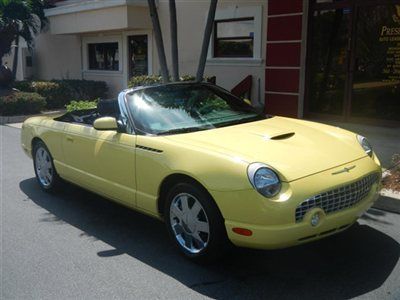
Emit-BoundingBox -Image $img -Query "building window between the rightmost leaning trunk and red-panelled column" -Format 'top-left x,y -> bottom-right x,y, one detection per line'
214,18 -> 254,57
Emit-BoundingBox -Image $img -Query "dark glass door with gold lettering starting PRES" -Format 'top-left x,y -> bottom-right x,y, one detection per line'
350,3 -> 400,121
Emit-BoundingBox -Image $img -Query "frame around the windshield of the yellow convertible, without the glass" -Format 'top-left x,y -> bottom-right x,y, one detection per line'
123,81 -> 273,136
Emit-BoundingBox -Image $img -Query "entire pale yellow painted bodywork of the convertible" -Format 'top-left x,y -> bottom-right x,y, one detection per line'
21,117 -> 381,248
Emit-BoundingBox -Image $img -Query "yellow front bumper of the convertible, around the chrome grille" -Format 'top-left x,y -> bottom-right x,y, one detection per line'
211,157 -> 381,249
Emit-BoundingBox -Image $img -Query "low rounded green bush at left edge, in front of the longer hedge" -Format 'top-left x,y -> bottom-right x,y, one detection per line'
0,92 -> 46,116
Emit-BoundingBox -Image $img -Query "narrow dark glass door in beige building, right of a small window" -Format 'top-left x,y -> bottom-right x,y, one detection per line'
128,35 -> 149,78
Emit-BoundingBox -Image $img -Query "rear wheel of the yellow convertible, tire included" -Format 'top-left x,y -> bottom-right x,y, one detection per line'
33,141 -> 62,192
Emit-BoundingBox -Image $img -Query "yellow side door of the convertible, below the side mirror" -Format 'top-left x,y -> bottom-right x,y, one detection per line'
62,123 -> 136,206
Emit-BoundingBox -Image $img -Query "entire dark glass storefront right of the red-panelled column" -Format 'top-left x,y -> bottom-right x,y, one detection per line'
304,0 -> 400,125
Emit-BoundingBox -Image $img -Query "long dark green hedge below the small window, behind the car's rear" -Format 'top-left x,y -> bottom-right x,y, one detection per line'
14,79 -> 108,109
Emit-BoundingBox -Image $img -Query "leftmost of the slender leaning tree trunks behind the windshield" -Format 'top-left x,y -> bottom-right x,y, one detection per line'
148,0 -> 169,83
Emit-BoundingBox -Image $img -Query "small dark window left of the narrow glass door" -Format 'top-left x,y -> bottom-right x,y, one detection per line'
88,42 -> 119,71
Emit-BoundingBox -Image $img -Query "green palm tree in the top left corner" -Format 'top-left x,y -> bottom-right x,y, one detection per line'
0,0 -> 51,79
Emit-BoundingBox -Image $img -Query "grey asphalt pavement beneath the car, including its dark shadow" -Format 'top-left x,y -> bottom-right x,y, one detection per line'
0,126 -> 400,299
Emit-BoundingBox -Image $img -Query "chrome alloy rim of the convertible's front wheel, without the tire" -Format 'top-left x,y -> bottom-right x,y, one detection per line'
169,193 -> 210,254
